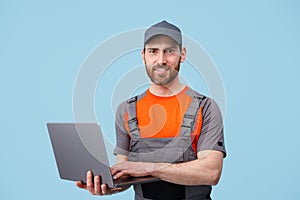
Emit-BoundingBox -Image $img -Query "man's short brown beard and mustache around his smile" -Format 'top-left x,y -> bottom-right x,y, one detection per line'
146,62 -> 180,86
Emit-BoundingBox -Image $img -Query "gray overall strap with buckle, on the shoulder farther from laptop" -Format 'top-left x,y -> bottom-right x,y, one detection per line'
180,89 -> 206,136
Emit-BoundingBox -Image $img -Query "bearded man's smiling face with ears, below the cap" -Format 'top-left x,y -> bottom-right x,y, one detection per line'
142,35 -> 186,86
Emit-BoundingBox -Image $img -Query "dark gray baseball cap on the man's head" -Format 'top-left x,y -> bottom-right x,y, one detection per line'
144,20 -> 182,46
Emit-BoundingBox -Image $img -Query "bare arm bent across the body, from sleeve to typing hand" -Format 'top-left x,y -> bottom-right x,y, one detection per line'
112,150 -> 223,185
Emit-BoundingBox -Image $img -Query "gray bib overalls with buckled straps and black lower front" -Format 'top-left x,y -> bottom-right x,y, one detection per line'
127,89 -> 211,200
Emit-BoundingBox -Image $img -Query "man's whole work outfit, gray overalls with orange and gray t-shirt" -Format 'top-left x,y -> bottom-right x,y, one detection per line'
114,87 -> 226,200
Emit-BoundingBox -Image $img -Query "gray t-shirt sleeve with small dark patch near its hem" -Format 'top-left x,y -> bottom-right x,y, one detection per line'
197,98 -> 226,157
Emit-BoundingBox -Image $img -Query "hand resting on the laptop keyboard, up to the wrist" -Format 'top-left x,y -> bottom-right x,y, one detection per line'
111,161 -> 161,179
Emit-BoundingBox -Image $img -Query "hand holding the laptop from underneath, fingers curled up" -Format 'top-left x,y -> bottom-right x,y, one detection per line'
76,171 -> 126,195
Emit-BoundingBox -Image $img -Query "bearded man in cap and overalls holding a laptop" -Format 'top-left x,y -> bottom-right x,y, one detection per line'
76,21 -> 226,200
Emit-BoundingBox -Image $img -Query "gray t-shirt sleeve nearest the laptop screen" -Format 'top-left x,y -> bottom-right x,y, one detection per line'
113,102 -> 130,155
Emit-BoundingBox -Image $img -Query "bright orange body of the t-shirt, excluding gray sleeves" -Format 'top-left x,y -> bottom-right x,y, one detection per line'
124,87 -> 202,152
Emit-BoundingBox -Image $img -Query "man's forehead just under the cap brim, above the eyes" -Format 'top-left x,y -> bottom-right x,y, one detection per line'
145,35 -> 179,48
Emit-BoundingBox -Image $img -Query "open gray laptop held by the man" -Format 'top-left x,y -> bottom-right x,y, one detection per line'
47,123 -> 160,188
